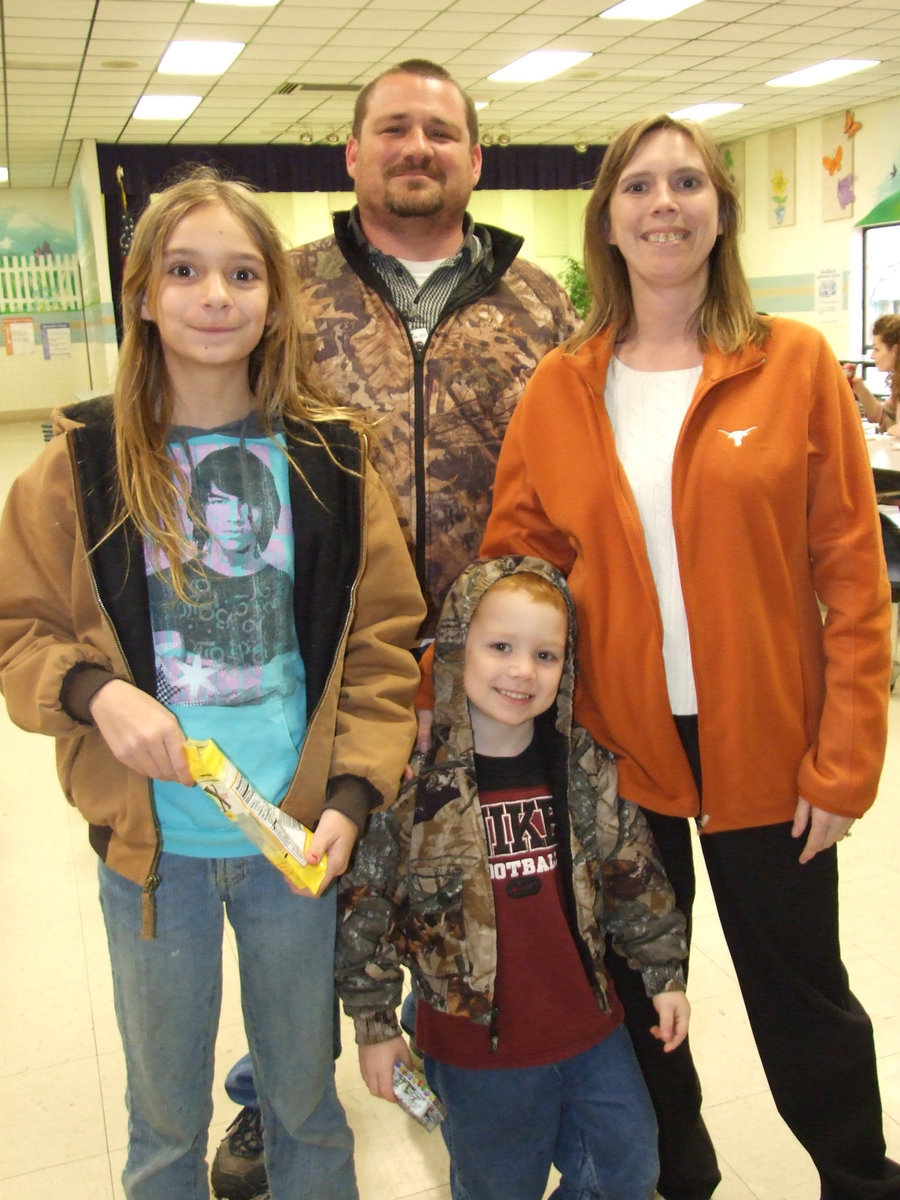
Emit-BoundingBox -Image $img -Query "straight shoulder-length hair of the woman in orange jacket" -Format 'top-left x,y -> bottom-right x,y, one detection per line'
566,115 -> 768,353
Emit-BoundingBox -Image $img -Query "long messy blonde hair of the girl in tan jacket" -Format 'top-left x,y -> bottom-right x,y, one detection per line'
110,167 -> 362,599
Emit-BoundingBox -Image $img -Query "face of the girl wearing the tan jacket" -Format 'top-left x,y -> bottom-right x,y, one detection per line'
140,203 -> 269,384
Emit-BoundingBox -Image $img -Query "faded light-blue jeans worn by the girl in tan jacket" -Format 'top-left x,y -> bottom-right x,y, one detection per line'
100,854 -> 358,1200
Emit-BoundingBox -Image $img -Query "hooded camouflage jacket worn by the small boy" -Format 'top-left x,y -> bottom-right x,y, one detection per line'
336,556 -> 686,1044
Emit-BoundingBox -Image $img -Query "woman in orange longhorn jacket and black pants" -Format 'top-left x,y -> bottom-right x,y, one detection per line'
481,116 -> 900,1200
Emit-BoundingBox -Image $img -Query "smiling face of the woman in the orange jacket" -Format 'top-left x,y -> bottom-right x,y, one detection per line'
607,130 -> 721,300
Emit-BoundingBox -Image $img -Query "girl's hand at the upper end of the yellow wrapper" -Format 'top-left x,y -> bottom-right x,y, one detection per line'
89,679 -> 194,787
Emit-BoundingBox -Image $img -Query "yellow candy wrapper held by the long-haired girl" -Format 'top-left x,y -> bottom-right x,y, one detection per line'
185,738 -> 328,895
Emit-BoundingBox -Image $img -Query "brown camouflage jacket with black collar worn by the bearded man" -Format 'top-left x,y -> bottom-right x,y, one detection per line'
292,212 -> 578,631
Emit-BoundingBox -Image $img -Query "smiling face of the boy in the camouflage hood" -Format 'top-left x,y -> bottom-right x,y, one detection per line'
463,588 -> 568,756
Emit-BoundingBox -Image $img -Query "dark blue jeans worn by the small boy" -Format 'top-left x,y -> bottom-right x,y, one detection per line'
425,1026 -> 662,1200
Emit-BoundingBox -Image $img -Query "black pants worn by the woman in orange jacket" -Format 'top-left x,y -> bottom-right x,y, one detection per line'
607,720 -> 900,1200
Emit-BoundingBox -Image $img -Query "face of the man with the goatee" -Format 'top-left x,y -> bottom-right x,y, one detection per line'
347,74 -> 481,222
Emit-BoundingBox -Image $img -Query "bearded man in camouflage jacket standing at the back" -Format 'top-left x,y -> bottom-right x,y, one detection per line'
211,60 -> 578,1200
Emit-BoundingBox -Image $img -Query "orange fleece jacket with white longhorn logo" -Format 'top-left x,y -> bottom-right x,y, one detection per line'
481,318 -> 890,833
